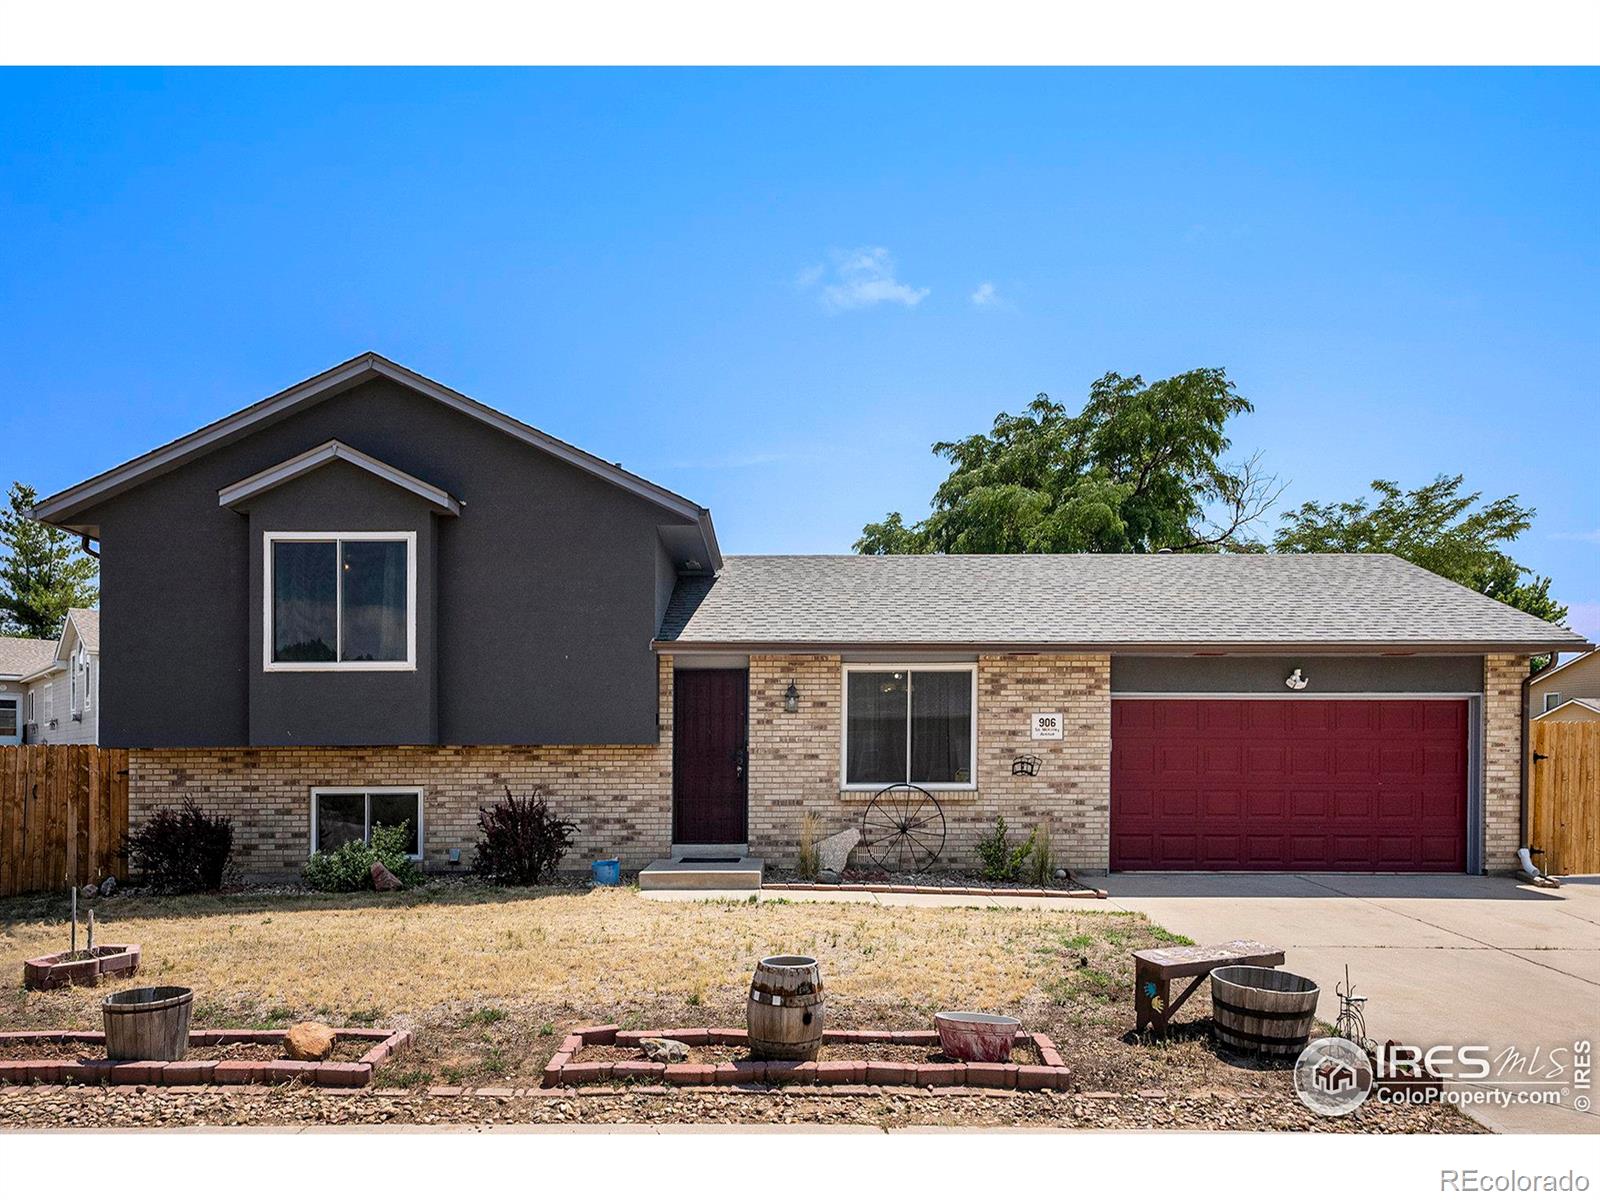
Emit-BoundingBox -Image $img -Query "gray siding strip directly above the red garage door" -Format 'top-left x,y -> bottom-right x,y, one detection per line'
1110,654 -> 1483,698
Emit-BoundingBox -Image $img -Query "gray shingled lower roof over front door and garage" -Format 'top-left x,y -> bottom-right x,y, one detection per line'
658,554 -> 1589,653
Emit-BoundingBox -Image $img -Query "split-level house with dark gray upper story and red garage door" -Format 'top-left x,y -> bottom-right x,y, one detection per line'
25,354 -> 1587,872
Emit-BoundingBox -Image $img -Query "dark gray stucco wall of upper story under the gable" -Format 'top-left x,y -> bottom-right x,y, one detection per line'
88,379 -> 686,747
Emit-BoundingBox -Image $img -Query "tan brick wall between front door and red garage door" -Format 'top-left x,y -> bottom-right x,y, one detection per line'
750,654 -> 1110,870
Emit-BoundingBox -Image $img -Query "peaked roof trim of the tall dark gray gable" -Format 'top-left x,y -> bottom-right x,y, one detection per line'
32,350 -> 722,570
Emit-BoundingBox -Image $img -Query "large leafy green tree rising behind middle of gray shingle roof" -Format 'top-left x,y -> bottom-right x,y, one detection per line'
854,370 -> 1280,554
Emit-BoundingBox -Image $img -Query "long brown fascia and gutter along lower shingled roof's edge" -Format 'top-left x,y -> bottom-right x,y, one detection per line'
650,638 -> 1594,658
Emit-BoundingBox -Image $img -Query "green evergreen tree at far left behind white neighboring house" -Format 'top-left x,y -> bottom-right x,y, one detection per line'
0,483 -> 99,637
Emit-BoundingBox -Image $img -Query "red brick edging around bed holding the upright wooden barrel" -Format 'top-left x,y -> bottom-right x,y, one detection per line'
544,1026 -> 1072,1091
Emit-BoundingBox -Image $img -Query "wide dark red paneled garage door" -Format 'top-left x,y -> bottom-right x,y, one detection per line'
1110,699 -> 1467,870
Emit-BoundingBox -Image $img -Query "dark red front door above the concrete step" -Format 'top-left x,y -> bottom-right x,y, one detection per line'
672,670 -> 750,845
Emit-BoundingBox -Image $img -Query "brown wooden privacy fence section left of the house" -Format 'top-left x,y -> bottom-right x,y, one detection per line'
0,746 -> 128,896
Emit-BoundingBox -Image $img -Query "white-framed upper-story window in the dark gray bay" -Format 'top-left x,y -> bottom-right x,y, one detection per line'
261,530 -> 416,670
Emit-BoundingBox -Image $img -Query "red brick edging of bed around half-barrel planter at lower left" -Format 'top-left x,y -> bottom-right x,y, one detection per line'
0,1029 -> 411,1088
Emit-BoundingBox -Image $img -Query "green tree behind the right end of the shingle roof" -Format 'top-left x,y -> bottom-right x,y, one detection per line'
1272,475 -> 1566,624
